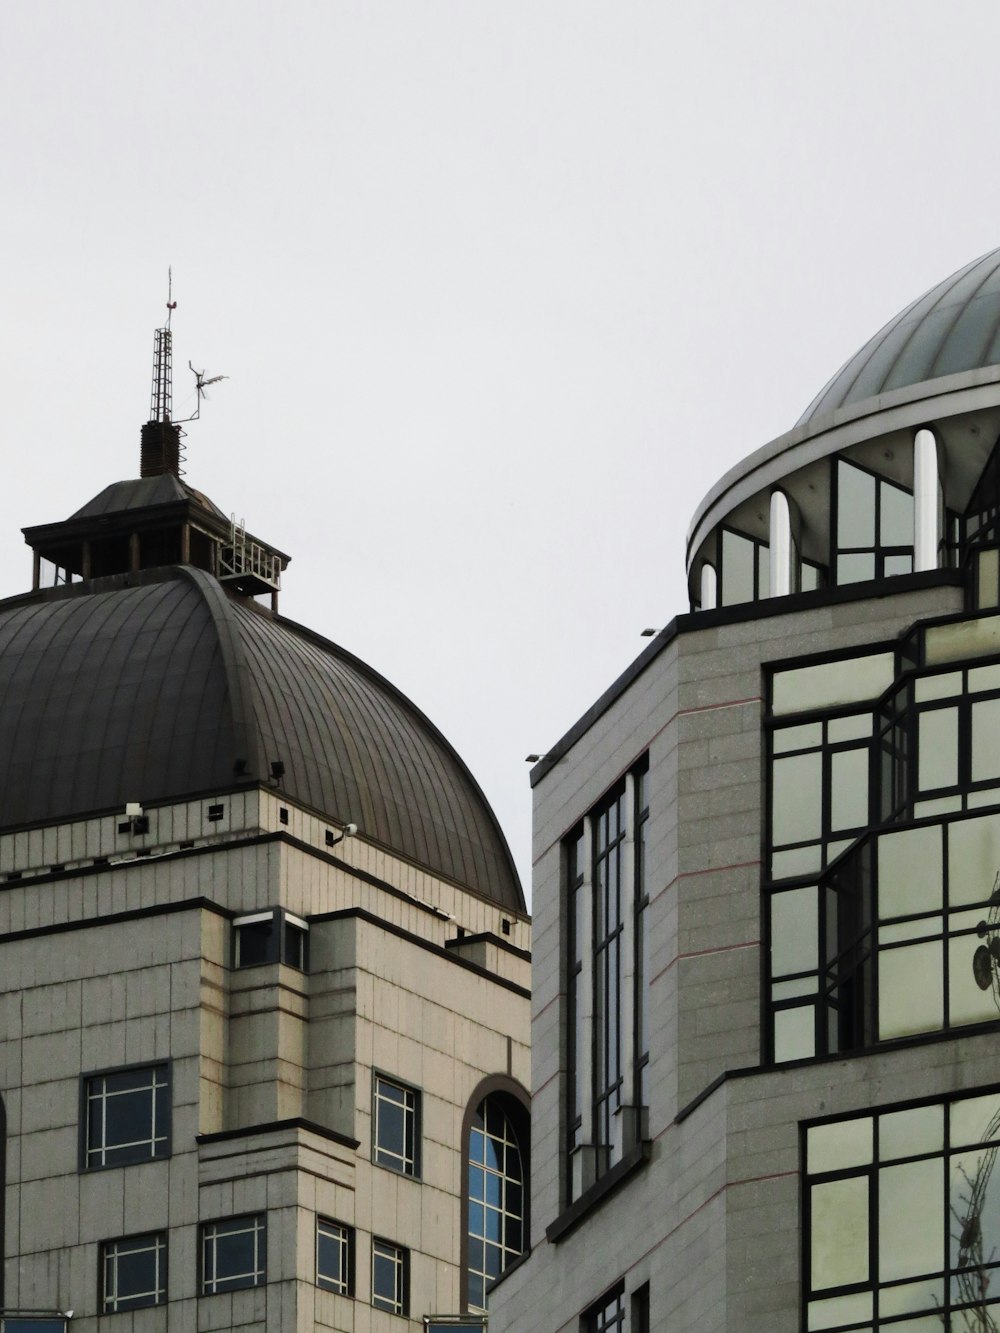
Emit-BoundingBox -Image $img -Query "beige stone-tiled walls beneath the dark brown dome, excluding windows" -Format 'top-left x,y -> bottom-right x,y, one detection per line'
0,789 -> 529,1333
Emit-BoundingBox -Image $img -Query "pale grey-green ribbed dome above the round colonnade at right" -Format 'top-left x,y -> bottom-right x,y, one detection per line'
797,249 -> 1000,425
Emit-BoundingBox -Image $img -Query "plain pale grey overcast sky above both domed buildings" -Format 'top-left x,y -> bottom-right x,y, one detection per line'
0,0 -> 1000,893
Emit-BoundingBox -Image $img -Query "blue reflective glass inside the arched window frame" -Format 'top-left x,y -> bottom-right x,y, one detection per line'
467,1097 -> 524,1310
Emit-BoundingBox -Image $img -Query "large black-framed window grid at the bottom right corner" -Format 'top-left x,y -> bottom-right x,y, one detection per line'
803,1092 -> 1000,1333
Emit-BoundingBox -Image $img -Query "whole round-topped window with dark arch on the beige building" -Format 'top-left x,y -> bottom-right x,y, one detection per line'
463,1080 -> 528,1312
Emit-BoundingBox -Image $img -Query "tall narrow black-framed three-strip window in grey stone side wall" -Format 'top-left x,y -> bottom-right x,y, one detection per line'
564,758 -> 649,1194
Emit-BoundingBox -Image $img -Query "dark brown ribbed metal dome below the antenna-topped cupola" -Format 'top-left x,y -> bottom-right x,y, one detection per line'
0,567 -> 524,910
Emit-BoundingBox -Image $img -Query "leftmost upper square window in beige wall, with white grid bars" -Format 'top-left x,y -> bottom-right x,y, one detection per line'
81,1064 -> 171,1169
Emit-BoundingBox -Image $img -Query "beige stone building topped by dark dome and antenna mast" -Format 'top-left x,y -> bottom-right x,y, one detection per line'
0,317 -> 529,1333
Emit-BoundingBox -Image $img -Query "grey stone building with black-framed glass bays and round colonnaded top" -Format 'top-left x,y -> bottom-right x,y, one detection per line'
491,251 -> 1000,1333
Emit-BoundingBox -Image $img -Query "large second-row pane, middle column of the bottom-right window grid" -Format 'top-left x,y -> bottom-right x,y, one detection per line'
879,1157 -> 944,1282
